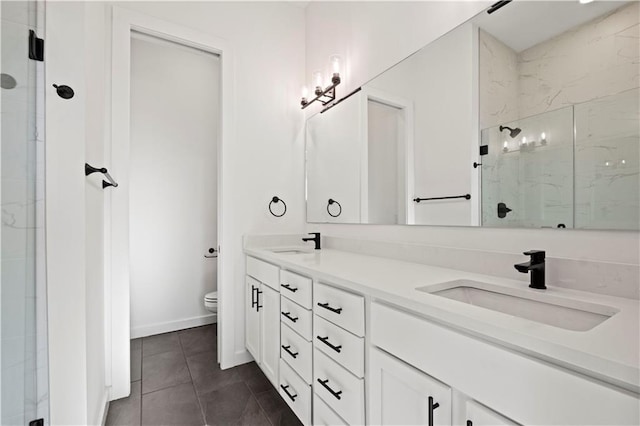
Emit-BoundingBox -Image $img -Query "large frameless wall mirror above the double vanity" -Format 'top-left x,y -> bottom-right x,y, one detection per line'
306,0 -> 640,230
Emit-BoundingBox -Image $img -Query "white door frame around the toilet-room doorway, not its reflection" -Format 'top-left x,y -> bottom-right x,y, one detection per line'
109,6 -> 234,400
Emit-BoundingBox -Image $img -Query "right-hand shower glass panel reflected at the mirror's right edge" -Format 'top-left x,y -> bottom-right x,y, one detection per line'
575,89 -> 640,229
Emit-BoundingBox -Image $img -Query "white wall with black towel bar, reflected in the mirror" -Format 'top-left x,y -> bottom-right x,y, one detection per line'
366,24 -> 478,225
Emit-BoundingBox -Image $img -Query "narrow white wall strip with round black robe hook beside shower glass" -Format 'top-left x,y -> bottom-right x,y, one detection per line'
45,2 -> 90,424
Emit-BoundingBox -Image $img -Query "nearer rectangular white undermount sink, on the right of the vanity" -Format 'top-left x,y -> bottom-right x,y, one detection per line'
416,280 -> 618,331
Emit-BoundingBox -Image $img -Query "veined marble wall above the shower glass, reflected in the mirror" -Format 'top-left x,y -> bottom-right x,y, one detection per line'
479,2 -> 640,129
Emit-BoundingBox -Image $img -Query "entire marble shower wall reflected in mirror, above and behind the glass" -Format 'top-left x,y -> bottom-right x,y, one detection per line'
479,2 -> 640,229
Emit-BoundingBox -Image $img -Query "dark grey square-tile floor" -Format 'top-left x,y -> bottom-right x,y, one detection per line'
106,325 -> 301,426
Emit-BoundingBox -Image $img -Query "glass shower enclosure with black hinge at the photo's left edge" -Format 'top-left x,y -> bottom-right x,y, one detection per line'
0,1 -> 49,425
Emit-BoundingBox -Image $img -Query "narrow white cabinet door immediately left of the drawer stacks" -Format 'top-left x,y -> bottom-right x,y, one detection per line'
259,284 -> 280,387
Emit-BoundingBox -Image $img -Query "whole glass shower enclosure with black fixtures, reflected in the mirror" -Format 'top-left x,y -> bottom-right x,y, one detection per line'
481,89 -> 640,230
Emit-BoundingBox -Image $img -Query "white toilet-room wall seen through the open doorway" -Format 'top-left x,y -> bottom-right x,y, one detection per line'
129,31 -> 220,338
